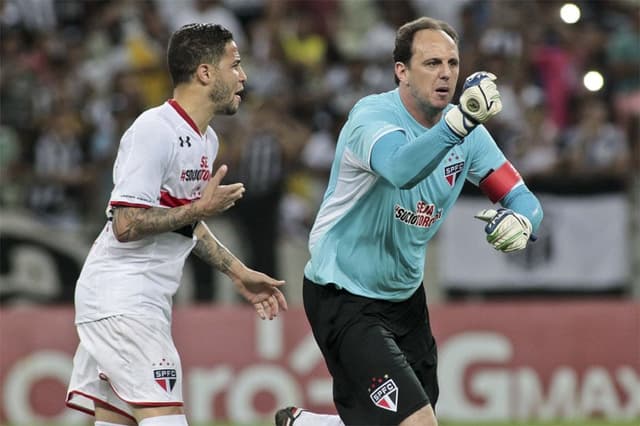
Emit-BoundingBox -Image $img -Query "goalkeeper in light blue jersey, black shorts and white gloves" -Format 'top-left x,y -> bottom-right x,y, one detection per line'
275,17 -> 542,426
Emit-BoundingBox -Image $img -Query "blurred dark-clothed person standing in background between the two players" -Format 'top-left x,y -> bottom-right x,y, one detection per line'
227,92 -> 310,276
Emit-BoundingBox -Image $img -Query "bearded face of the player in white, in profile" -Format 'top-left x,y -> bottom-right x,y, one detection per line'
209,41 -> 247,115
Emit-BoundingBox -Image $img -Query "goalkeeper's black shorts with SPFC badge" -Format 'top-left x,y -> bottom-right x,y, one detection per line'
303,278 -> 438,425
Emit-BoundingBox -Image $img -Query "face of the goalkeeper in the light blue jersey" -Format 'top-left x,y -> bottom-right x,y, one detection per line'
396,30 -> 460,112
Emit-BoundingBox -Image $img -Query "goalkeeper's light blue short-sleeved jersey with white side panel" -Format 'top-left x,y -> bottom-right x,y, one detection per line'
304,89 -> 506,301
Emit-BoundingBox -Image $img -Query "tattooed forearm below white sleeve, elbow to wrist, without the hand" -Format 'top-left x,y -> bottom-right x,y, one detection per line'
113,206 -> 200,242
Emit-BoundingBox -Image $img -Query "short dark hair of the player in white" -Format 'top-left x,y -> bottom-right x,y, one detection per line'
167,24 -> 233,87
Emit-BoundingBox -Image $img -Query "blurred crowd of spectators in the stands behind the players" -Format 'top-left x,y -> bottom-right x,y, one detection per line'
0,0 -> 640,256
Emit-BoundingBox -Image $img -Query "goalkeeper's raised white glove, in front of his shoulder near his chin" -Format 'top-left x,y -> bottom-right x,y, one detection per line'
444,71 -> 502,138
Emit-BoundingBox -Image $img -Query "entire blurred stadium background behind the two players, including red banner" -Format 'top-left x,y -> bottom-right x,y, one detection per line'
0,0 -> 640,426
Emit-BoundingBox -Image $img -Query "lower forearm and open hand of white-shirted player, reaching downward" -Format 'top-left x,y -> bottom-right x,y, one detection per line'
193,221 -> 287,319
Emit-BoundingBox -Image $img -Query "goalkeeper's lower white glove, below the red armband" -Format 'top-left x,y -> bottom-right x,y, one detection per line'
474,208 -> 535,252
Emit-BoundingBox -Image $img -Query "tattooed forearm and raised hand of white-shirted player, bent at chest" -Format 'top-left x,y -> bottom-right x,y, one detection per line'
113,165 -> 245,242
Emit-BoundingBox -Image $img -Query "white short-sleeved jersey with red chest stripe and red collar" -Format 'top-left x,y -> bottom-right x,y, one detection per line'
75,100 -> 218,323
